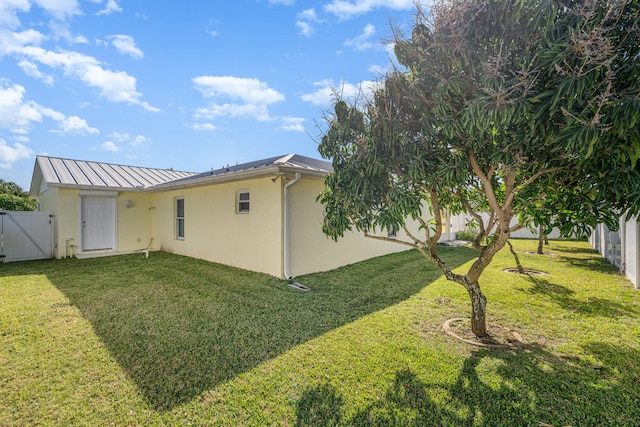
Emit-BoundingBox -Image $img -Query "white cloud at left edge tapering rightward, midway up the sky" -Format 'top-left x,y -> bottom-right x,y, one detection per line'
0,85 -> 99,135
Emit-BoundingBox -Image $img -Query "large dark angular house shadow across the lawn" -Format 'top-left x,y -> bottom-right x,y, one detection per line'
36,251 -> 472,411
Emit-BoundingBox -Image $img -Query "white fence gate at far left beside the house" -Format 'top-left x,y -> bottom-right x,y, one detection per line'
0,211 -> 53,262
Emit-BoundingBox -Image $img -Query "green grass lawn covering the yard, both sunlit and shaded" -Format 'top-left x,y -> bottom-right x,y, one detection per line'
0,240 -> 640,427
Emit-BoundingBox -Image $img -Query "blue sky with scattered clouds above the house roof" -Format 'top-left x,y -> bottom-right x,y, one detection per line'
0,0 -> 415,189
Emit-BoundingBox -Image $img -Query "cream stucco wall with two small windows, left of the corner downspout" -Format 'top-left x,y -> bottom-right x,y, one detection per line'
152,177 -> 282,277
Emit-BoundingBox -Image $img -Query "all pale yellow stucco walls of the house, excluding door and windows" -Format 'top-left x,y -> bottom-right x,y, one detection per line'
40,172 -> 468,277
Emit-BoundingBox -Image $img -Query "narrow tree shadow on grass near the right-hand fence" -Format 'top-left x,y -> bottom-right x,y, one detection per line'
521,276 -> 640,318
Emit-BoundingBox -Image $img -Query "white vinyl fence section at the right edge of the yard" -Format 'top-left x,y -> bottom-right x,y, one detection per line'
589,217 -> 640,289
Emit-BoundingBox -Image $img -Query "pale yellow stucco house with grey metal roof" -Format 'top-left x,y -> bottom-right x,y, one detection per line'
30,154 -> 440,278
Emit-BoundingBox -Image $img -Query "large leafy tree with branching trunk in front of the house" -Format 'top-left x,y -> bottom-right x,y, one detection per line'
319,0 -> 640,336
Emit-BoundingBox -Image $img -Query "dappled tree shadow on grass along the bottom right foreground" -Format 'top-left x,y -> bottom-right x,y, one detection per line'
296,343 -> 640,427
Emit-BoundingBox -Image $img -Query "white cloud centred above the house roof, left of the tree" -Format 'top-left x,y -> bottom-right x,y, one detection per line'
192,76 -> 284,121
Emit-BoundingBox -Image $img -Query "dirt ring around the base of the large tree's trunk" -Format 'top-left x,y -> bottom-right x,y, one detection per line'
442,317 -> 525,350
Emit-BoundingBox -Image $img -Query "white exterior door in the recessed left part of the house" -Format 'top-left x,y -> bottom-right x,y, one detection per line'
80,196 -> 116,251
